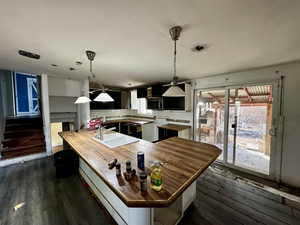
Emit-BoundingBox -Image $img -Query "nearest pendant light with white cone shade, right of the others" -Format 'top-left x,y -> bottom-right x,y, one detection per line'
162,26 -> 185,97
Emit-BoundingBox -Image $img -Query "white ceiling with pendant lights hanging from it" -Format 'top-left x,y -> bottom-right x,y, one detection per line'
0,0 -> 300,87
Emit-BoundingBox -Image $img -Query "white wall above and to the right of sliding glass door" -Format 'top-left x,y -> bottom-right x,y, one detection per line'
194,61 -> 300,187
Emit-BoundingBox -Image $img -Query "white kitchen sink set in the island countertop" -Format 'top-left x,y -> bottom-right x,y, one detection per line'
93,133 -> 139,148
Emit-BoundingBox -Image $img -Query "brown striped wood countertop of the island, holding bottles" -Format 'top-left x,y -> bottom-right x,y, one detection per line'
60,130 -> 221,207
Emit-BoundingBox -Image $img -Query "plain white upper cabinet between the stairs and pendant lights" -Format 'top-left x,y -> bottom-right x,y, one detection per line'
48,77 -> 81,97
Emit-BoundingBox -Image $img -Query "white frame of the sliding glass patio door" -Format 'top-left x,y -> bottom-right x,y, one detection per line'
193,79 -> 284,182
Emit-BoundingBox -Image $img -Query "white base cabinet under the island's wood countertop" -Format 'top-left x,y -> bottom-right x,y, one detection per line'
79,159 -> 196,225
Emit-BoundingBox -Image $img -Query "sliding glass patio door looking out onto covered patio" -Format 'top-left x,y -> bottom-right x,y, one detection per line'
194,82 -> 279,178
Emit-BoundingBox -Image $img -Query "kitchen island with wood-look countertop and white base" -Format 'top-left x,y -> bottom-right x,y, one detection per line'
60,130 -> 221,225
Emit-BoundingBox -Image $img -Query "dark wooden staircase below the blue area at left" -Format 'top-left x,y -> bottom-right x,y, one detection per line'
1,117 -> 45,159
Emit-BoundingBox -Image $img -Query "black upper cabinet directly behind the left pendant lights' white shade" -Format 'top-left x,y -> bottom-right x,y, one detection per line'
90,91 -> 122,110
